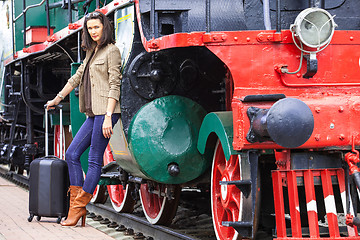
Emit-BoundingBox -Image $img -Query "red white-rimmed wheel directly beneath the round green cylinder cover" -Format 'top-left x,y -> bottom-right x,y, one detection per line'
139,182 -> 181,226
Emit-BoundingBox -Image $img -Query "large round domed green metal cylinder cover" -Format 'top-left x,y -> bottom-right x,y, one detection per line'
128,96 -> 211,184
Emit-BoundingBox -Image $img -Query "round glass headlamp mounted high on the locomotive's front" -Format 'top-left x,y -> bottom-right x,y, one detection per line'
290,8 -> 337,52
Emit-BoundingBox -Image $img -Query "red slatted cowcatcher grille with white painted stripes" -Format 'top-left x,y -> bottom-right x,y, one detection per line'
272,168 -> 360,240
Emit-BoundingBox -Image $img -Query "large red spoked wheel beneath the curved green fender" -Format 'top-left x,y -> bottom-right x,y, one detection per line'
211,142 -> 242,240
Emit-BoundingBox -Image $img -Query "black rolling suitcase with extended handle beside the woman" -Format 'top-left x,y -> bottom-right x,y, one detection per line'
28,106 -> 69,223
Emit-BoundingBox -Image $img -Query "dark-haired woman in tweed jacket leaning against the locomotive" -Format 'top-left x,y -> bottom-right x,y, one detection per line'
47,12 -> 121,226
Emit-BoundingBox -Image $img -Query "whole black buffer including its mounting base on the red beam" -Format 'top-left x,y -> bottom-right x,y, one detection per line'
246,98 -> 314,148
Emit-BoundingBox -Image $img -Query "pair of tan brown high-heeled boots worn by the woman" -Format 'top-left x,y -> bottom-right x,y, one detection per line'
60,188 -> 92,227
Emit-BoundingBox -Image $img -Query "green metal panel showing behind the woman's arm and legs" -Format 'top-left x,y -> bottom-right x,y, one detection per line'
70,63 -> 89,173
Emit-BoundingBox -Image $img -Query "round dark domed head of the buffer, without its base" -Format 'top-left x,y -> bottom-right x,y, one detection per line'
266,98 -> 314,148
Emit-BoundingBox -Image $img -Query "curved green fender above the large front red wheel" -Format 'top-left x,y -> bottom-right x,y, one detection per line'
198,112 -> 239,160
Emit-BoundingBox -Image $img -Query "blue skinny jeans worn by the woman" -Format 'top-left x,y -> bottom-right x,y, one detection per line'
65,113 -> 120,194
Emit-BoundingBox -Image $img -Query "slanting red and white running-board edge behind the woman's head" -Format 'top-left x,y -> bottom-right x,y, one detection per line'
4,0 -> 132,65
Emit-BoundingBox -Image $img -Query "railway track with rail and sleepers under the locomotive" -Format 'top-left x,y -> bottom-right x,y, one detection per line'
0,165 -> 216,240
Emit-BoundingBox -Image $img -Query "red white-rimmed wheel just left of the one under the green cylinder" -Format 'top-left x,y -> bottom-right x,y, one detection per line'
104,145 -> 135,213
